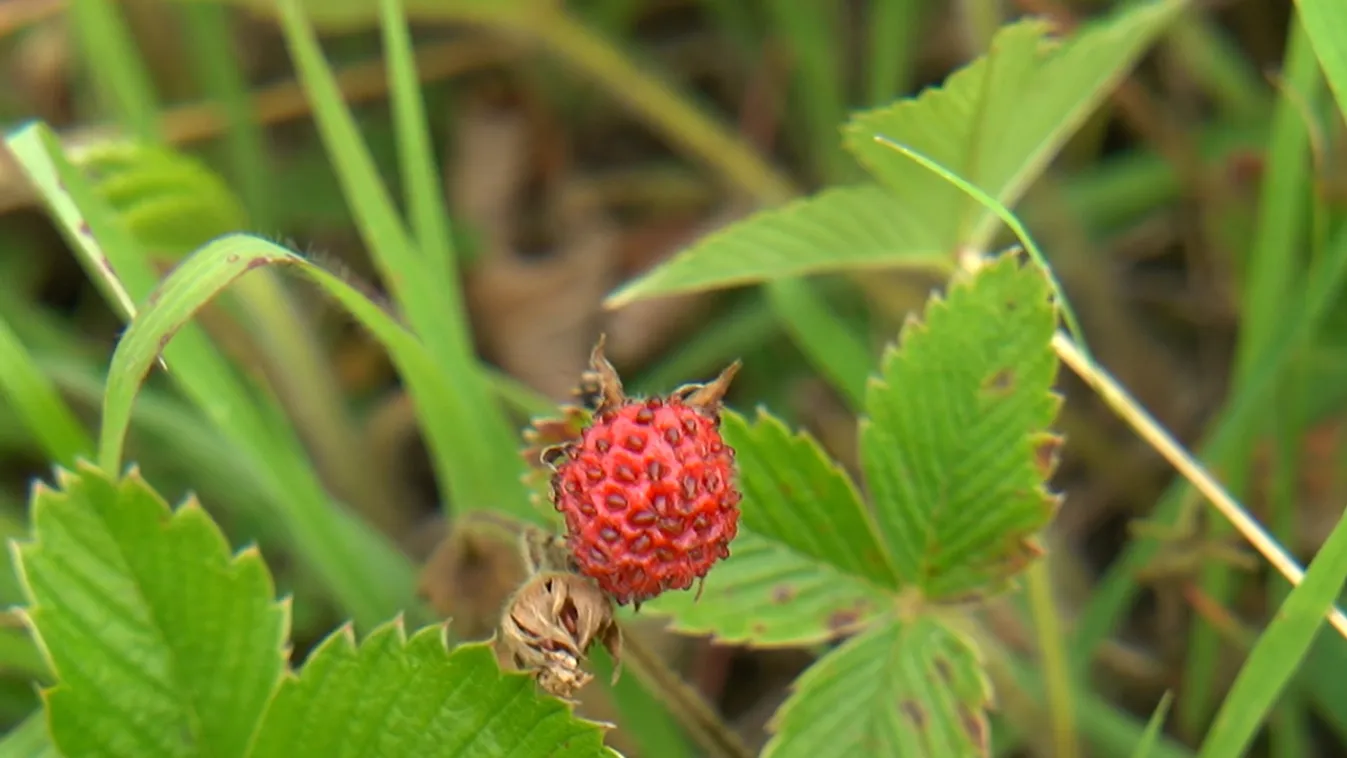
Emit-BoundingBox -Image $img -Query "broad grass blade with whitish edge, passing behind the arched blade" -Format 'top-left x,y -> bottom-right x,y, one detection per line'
8,124 -> 416,626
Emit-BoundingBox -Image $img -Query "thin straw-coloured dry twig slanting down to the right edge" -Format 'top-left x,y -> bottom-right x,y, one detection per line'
1052,331 -> 1347,637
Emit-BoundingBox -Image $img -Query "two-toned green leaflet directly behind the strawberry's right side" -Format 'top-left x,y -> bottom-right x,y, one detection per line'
641,411 -> 897,645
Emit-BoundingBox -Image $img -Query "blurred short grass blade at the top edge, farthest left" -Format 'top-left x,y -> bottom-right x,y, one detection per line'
70,0 -> 160,143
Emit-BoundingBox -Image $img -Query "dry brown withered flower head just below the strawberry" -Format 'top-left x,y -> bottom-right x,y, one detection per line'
496,570 -> 622,699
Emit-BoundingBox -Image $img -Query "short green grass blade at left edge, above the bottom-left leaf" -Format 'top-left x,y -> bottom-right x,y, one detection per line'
0,319 -> 93,466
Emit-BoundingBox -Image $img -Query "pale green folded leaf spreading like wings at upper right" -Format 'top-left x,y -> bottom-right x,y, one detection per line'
607,0 -> 1184,307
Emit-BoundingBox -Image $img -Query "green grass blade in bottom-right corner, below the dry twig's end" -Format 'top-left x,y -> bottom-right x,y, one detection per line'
1199,506 -> 1347,758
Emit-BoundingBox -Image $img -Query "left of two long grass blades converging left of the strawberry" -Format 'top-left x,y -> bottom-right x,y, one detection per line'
280,0 -> 536,520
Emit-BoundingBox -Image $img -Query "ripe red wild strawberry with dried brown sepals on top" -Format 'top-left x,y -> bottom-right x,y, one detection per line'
551,339 -> 741,607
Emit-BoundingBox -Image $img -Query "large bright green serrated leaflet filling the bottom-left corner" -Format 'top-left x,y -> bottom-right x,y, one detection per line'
15,464 -> 288,758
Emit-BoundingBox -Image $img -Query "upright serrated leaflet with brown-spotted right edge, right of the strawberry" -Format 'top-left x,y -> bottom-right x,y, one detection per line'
861,254 -> 1060,599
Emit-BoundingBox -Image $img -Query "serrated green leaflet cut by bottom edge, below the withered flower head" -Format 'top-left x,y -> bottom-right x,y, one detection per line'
251,619 -> 613,758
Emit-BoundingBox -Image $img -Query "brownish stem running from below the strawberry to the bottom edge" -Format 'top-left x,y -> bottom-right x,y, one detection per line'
622,625 -> 753,758
